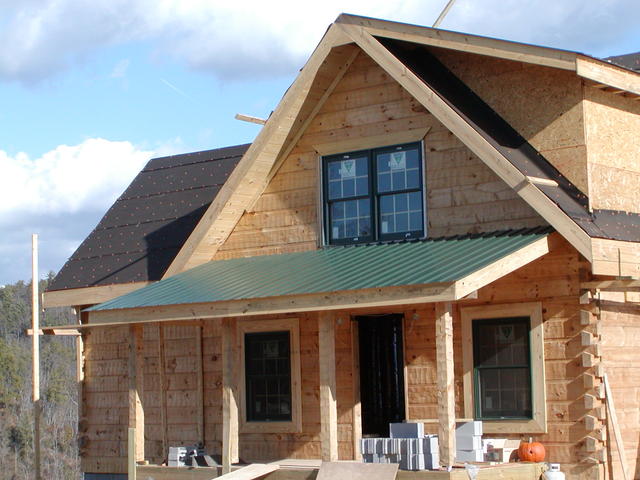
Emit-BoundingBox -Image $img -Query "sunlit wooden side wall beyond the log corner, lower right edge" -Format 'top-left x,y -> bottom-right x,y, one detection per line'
600,302 -> 640,478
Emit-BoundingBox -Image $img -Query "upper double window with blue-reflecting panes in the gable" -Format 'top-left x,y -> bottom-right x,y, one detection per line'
323,143 -> 424,244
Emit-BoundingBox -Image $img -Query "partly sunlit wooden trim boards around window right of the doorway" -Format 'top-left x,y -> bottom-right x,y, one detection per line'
460,302 -> 547,433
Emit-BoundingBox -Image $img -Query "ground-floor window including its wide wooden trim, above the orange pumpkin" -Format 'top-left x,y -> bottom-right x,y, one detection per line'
460,302 -> 547,433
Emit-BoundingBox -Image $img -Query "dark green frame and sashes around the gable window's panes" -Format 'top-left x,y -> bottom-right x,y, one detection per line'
319,139 -> 427,246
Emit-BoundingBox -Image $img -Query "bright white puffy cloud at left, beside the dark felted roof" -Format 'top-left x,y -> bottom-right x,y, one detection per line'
0,138 -> 152,220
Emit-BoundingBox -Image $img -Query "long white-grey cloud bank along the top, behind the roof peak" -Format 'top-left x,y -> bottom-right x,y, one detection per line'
0,0 -> 640,82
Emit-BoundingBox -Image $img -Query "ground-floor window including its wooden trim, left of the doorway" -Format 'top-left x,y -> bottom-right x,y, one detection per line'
238,318 -> 302,433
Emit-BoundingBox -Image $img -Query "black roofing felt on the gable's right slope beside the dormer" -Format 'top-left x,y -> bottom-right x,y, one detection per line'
378,37 -> 640,242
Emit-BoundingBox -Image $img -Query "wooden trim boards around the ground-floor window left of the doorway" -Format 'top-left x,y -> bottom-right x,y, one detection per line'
237,318 -> 302,433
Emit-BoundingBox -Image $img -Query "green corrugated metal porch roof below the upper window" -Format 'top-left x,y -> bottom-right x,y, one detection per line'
89,228 -> 550,310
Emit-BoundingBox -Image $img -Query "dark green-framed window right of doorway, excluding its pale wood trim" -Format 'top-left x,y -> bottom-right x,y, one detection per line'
473,317 -> 532,420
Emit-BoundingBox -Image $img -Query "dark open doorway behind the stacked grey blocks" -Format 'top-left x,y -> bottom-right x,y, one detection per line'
356,314 -> 405,437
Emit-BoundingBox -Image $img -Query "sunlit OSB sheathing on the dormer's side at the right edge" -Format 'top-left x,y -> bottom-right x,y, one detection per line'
585,87 -> 640,212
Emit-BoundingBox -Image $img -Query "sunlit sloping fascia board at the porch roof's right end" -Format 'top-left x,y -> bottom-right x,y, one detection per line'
456,234 -> 556,297
